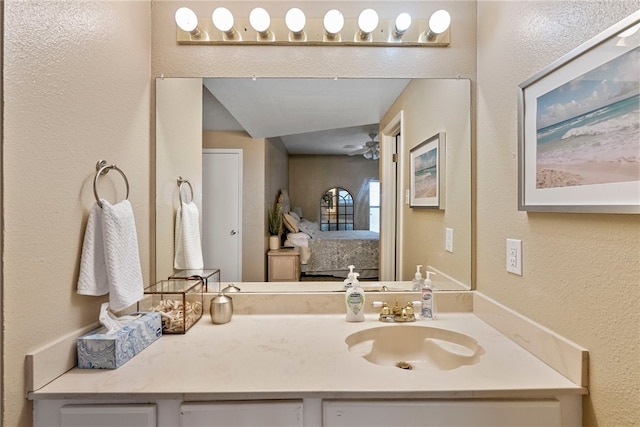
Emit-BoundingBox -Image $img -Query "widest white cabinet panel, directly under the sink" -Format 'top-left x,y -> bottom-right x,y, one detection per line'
323,399 -> 561,427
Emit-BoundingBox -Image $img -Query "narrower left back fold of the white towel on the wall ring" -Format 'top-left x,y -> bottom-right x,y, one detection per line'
78,203 -> 109,295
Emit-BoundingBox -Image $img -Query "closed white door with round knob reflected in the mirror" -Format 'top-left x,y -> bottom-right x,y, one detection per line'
202,149 -> 242,282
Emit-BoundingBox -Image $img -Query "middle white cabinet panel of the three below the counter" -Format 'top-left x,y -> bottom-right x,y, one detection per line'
180,400 -> 302,427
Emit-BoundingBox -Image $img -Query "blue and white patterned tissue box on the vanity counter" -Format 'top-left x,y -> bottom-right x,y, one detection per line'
77,313 -> 162,369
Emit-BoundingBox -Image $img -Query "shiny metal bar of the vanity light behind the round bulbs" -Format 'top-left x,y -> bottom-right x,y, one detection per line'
176,17 -> 451,47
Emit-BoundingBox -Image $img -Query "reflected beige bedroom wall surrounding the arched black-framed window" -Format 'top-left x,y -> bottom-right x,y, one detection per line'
289,155 -> 380,230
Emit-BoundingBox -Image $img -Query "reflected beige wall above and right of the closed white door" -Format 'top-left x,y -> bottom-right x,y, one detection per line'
202,132 -> 267,282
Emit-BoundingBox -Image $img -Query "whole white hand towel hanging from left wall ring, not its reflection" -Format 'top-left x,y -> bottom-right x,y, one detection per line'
78,200 -> 144,311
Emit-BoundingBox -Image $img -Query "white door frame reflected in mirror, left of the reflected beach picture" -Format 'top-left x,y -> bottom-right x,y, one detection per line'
380,110 -> 405,281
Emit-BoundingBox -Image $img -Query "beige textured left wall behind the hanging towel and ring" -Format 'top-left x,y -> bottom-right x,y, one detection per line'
2,0 -> 152,426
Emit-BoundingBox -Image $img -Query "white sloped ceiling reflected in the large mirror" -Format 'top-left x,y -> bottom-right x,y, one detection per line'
203,78 -> 410,155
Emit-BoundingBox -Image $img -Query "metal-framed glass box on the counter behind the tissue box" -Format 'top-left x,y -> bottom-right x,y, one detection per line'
138,279 -> 204,334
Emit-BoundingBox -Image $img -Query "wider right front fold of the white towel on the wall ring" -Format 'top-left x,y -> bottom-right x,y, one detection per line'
101,200 -> 144,311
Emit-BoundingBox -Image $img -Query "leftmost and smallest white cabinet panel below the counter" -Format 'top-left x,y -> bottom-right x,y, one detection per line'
60,404 -> 156,427
